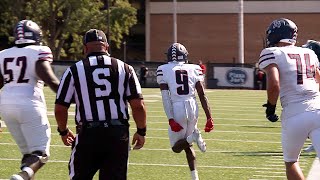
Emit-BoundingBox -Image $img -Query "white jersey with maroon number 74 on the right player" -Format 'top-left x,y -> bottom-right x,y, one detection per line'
259,46 -> 320,107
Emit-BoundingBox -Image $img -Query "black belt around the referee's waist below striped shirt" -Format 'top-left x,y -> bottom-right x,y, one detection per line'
82,119 -> 129,129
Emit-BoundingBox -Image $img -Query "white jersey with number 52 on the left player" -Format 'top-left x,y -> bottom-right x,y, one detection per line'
0,45 -> 53,107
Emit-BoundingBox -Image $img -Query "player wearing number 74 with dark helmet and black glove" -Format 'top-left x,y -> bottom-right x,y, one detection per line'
259,18 -> 320,180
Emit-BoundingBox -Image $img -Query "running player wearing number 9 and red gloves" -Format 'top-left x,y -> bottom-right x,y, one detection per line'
157,43 -> 214,180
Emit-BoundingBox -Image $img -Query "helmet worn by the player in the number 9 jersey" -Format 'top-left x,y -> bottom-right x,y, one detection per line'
167,43 -> 188,63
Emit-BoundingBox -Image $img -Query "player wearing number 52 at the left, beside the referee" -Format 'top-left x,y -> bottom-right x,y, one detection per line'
0,20 -> 59,180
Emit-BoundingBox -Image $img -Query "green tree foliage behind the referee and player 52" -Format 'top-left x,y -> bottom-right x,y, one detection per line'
0,0 -> 137,59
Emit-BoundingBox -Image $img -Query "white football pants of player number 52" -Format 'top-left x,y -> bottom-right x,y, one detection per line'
0,104 -> 51,156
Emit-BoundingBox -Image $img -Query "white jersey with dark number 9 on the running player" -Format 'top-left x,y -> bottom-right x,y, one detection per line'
157,62 -> 203,102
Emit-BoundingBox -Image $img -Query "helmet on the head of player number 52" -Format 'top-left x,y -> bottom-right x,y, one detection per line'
13,20 -> 42,45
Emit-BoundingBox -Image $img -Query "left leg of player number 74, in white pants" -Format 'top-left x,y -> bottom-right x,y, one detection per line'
281,112 -> 313,180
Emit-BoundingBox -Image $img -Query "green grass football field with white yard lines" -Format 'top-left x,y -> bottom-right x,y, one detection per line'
0,88 -> 316,180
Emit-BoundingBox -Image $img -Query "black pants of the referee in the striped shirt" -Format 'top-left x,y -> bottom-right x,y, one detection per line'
69,126 -> 129,180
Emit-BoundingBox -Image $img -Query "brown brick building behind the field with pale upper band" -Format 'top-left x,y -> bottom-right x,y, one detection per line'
145,0 -> 320,64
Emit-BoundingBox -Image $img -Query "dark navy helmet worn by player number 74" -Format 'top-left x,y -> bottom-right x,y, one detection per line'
266,18 -> 298,47
